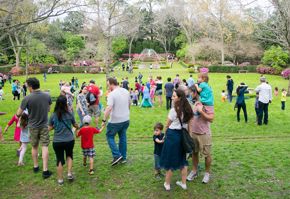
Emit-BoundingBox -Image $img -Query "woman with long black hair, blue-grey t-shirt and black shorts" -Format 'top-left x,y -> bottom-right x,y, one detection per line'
48,95 -> 78,185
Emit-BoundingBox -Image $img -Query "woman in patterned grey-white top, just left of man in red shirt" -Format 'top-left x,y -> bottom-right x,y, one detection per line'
77,87 -> 89,126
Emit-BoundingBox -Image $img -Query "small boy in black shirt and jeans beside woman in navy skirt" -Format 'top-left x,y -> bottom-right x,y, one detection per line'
153,122 -> 164,178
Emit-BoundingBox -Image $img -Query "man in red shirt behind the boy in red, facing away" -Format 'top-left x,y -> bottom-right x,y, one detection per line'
87,80 -> 101,126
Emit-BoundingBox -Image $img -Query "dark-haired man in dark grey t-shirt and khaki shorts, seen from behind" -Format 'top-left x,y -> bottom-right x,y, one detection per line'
16,77 -> 52,179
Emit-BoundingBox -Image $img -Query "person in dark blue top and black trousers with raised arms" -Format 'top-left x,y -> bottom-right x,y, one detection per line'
236,83 -> 248,122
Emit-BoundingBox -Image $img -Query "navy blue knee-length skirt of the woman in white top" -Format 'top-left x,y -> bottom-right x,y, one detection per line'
160,129 -> 188,171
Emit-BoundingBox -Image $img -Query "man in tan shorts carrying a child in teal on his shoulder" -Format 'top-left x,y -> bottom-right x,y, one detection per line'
187,86 -> 214,184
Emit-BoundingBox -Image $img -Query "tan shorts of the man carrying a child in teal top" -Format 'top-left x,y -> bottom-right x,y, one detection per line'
191,133 -> 212,157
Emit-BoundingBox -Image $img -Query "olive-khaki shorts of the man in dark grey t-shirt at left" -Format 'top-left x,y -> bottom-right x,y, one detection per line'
29,127 -> 49,147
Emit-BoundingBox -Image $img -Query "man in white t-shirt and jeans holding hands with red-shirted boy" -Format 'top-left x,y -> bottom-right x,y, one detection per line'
102,77 -> 131,166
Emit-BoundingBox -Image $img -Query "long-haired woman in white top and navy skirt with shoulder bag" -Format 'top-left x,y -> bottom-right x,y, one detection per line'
160,89 -> 192,191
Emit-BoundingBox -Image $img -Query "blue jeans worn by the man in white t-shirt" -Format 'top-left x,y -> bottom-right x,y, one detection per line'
106,120 -> 130,159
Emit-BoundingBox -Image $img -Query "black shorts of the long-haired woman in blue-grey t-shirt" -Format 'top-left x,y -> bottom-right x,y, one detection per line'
52,140 -> 75,166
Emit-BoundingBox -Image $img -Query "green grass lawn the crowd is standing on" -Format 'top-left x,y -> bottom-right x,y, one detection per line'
0,64 -> 290,199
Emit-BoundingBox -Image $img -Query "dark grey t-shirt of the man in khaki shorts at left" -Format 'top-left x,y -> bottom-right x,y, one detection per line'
20,91 -> 52,128
